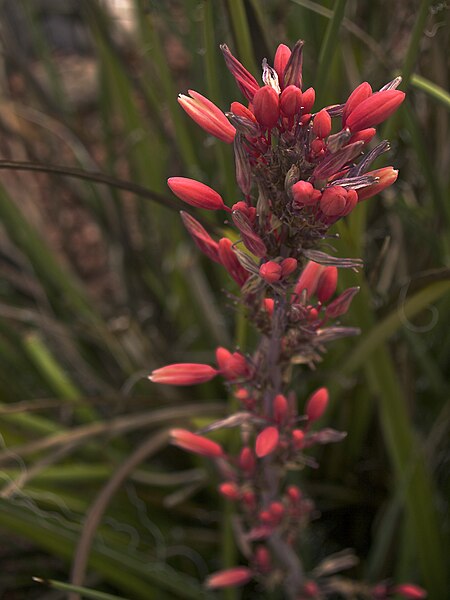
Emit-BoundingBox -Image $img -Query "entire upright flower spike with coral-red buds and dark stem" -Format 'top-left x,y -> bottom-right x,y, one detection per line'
150,41 -> 426,600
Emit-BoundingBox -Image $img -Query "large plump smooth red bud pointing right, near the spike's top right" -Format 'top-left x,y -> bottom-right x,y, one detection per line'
345,90 -> 405,132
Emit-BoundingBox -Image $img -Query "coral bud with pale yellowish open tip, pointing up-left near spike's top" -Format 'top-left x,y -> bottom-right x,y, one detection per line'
178,90 -> 236,144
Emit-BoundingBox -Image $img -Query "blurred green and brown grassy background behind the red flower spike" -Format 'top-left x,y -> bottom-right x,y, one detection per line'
0,0 -> 450,600
